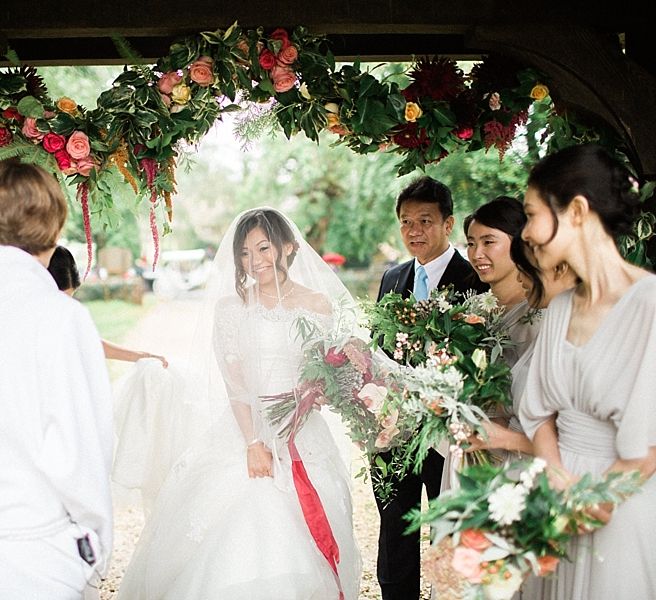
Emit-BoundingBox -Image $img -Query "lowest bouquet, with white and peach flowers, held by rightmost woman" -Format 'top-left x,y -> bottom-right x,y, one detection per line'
407,458 -> 639,600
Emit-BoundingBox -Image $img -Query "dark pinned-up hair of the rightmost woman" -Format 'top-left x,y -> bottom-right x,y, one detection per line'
528,144 -> 638,239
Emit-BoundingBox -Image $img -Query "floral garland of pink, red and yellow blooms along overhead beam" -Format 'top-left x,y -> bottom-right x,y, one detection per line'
0,23 -> 653,269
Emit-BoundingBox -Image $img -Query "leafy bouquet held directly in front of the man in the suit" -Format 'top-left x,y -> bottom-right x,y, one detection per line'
365,288 -> 510,470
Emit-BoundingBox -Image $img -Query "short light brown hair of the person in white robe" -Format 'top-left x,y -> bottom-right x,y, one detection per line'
0,159 -> 68,255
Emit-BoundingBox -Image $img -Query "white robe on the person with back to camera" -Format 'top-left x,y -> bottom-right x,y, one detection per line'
0,246 -> 113,572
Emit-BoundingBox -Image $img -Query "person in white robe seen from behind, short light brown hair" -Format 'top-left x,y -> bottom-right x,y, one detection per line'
0,161 -> 112,600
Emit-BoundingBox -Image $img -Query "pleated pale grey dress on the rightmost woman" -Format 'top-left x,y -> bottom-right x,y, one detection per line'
519,275 -> 656,600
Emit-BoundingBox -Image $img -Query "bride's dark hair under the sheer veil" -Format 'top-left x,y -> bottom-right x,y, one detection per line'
232,209 -> 298,301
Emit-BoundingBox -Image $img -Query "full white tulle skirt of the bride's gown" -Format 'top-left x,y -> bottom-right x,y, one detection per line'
119,413 -> 361,600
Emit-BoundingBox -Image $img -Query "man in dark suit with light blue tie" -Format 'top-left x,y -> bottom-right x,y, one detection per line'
376,177 -> 489,600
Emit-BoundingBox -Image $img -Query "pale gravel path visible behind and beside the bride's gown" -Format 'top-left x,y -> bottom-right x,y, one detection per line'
100,301 -> 430,600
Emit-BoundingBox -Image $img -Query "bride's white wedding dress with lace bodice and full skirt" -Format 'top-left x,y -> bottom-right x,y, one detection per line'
119,301 -> 360,600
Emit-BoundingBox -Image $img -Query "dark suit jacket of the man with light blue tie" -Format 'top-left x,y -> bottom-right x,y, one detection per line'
378,250 -> 490,300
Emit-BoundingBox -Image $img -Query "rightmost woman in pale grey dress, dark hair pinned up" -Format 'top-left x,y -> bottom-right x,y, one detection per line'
519,145 -> 656,600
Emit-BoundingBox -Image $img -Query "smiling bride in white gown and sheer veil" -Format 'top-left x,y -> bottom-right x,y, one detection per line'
117,208 -> 360,600
